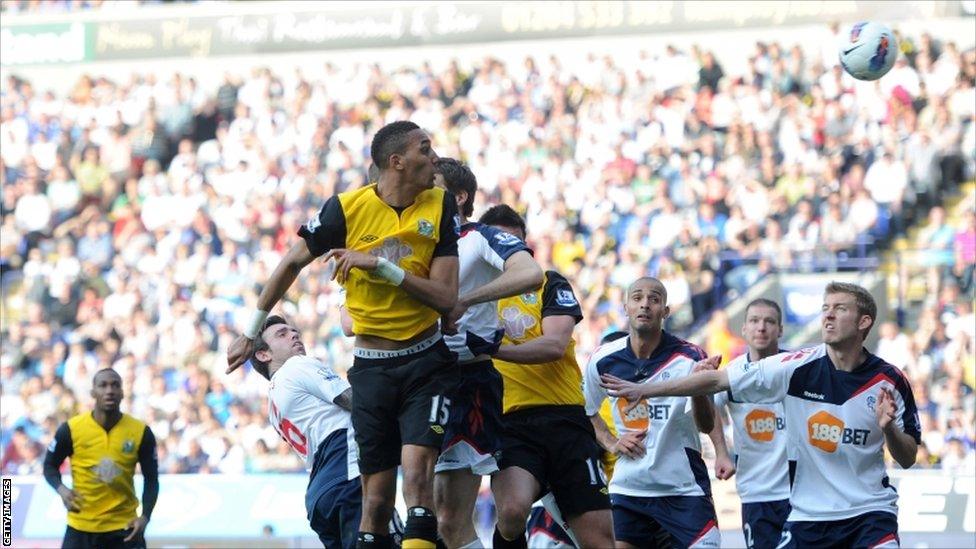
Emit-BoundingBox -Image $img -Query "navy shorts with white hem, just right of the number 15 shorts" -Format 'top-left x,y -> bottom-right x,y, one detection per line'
434,360 -> 502,475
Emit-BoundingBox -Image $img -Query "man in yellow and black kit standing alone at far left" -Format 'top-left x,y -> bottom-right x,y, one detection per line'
44,368 -> 159,549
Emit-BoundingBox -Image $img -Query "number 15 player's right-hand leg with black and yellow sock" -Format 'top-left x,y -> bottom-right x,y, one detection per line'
400,444 -> 438,549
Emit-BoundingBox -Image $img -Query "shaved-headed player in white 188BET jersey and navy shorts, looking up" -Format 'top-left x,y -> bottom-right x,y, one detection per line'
583,277 -> 724,548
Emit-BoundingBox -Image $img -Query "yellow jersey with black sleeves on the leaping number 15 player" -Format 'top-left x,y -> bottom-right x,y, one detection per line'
298,183 -> 460,341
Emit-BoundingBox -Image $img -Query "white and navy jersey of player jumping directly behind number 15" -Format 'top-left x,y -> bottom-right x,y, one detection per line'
444,223 -> 531,362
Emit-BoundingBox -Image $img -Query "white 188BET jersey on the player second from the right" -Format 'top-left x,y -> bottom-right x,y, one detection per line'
715,354 -> 790,503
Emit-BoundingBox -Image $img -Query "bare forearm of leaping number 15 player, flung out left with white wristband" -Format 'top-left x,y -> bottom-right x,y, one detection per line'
227,241 -> 315,374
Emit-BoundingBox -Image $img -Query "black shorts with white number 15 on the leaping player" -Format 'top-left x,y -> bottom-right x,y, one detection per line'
348,339 -> 457,475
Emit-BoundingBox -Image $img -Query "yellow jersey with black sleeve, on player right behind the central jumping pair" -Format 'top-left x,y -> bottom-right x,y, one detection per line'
494,271 -> 584,414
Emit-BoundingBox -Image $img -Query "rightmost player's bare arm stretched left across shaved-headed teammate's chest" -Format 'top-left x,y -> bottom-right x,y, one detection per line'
600,355 -> 729,411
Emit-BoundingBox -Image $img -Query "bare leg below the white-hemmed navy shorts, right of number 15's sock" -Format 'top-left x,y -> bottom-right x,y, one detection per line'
434,469 -> 481,549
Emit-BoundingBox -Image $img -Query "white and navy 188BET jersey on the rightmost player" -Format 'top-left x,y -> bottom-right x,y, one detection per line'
727,344 -> 921,521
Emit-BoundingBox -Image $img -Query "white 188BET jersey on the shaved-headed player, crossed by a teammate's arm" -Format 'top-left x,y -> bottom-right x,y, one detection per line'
583,332 -> 711,497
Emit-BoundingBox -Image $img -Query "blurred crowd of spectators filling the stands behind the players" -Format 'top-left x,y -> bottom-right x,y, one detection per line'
0,21 -> 976,474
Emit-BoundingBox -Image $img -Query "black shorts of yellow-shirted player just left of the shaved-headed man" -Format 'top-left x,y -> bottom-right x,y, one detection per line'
501,405 -> 610,519
